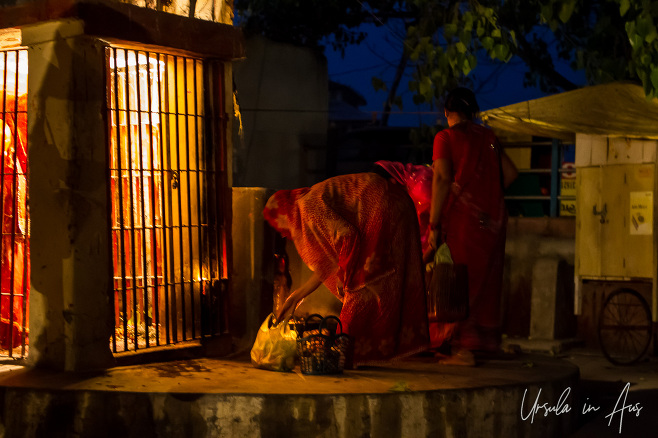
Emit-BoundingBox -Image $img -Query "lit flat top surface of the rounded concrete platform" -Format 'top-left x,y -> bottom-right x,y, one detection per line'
0,354 -> 577,394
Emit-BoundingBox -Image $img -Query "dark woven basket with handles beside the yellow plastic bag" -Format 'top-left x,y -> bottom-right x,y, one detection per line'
297,315 -> 351,374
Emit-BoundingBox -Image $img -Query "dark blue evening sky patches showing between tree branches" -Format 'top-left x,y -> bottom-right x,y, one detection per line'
325,25 -> 585,126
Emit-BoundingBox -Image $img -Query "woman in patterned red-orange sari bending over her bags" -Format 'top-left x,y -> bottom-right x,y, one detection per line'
263,173 -> 429,365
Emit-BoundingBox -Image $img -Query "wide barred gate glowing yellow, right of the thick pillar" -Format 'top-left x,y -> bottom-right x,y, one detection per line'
107,47 -> 224,353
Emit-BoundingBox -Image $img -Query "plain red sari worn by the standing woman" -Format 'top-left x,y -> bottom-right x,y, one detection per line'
432,122 -> 507,350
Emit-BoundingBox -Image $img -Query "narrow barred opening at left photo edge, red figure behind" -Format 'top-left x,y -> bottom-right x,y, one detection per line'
0,49 -> 30,357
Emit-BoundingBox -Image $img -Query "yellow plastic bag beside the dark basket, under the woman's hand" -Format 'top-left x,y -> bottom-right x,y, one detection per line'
251,313 -> 297,371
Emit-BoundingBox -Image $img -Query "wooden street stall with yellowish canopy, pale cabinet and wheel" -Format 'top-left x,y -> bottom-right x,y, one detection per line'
483,83 -> 658,364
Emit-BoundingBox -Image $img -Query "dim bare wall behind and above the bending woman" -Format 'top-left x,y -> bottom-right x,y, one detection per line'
233,37 -> 329,189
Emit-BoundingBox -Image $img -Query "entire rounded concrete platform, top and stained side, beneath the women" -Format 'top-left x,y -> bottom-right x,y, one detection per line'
0,354 -> 579,438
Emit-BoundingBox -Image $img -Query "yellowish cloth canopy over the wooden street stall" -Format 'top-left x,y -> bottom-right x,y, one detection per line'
481,82 -> 658,141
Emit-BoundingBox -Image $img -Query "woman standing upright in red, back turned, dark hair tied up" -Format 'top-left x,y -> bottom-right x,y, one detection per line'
428,87 -> 518,365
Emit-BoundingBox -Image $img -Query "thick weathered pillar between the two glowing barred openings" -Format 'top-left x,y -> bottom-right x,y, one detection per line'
23,20 -> 114,371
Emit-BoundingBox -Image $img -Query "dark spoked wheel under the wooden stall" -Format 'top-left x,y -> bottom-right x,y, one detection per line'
599,289 -> 652,365
